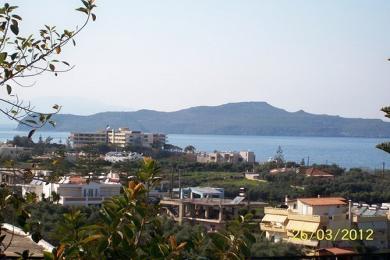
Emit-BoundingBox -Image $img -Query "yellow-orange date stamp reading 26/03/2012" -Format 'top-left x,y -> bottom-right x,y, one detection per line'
292,228 -> 374,241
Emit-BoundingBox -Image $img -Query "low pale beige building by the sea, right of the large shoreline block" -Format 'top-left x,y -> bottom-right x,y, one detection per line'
196,151 -> 255,164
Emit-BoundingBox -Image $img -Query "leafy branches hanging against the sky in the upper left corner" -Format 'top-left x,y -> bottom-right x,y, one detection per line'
0,0 -> 96,129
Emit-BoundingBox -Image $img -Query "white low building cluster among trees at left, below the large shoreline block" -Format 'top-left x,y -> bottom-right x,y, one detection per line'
22,173 -> 121,206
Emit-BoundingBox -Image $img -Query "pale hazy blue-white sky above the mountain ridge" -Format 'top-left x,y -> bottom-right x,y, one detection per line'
4,0 -> 390,118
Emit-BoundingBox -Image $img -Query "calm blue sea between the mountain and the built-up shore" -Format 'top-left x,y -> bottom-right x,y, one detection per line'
0,129 -> 390,170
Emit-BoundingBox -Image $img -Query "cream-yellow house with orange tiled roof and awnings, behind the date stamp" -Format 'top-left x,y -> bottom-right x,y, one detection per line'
260,197 -> 349,250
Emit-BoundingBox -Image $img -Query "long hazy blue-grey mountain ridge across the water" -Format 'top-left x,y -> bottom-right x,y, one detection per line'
17,102 -> 390,137
